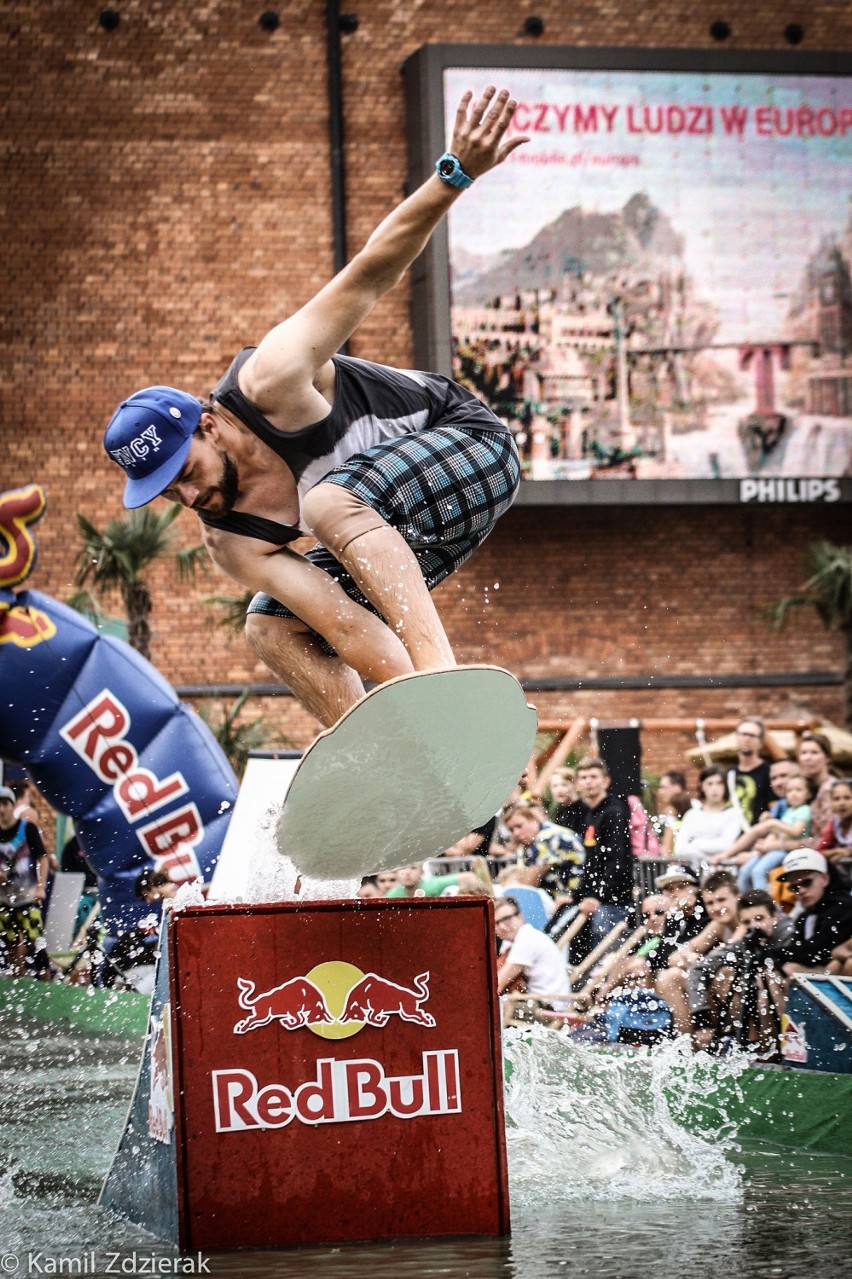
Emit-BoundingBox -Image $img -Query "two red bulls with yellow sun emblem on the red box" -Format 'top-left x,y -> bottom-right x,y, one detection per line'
234,961 -> 435,1039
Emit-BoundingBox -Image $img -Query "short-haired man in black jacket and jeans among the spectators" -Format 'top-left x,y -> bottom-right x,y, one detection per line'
558,756 -> 633,958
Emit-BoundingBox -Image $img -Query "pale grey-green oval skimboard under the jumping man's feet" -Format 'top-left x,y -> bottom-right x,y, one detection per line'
276,666 -> 537,879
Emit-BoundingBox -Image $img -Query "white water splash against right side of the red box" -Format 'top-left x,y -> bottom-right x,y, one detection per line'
504,1027 -> 745,1209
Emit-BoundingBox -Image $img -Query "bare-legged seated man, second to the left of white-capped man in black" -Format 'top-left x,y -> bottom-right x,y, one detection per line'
652,871 -> 737,1035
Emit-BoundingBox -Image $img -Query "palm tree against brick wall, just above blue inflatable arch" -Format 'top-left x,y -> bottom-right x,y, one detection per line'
68,503 -> 207,659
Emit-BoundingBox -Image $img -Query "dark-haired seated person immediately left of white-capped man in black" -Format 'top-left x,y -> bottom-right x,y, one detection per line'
687,889 -> 793,1051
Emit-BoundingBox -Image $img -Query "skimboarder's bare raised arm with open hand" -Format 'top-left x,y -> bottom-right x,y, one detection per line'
241,87 -> 528,414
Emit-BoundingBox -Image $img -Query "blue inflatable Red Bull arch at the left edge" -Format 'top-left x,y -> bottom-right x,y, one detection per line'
0,485 -> 237,935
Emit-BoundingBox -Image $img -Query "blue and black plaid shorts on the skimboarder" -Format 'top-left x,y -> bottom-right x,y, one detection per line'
248,426 -> 521,629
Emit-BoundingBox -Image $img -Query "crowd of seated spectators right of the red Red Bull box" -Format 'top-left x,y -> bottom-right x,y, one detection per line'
362,718 -> 852,1059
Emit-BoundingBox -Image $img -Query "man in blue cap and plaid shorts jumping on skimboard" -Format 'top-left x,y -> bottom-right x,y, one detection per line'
105,88 -> 528,726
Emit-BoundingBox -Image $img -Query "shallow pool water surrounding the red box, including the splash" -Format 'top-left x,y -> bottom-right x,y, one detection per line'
0,1007 -> 852,1279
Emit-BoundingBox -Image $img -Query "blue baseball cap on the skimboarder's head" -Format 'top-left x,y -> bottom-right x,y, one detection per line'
104,386 -> 202,510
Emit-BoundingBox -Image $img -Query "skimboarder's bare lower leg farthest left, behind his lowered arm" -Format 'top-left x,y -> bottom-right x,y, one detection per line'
246,613 -> 386,728
